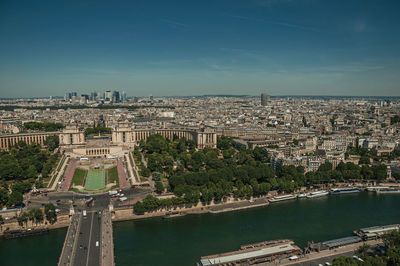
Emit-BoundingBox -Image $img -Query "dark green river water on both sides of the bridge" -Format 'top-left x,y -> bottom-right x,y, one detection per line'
0,192 -> 400,266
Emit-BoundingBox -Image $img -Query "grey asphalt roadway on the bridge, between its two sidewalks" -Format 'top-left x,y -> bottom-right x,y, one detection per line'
73,211 -> 101,266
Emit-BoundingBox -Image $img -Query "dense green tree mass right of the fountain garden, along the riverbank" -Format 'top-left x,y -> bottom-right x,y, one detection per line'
135,135 -> 387,214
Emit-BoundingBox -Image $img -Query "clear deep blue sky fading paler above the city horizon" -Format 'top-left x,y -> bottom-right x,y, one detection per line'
0,0 -> 400,98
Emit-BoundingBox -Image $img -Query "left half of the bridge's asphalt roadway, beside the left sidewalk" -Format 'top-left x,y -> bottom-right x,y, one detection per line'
73,213 -> 94,266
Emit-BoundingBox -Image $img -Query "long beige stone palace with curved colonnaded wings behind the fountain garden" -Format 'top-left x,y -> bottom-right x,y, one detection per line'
0,123 -> 217,156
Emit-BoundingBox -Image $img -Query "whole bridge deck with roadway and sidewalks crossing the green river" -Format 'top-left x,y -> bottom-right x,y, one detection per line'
58,210 -> 114,266
